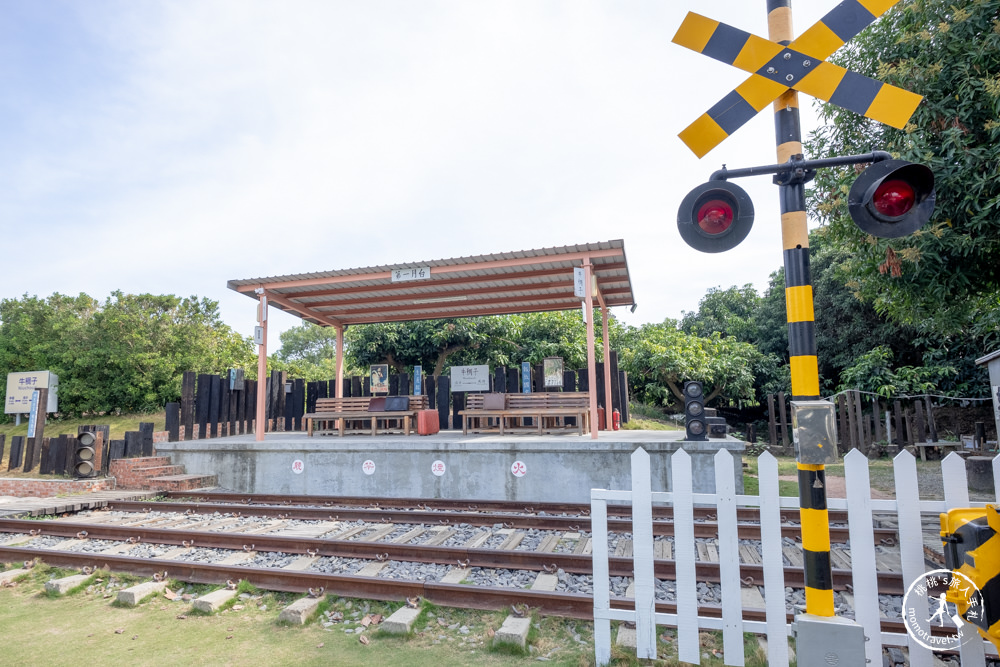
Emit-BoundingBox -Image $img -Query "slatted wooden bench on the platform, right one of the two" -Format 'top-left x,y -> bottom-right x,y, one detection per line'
458,391 -> 590,435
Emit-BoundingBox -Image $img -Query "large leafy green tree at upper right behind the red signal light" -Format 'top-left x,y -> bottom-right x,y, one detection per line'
807,0 -> 1000,342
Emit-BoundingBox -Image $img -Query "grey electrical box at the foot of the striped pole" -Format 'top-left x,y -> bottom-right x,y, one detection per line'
792,614 -> 868,667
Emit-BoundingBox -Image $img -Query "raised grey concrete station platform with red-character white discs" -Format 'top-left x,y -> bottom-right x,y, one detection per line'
156,431 -> 745,503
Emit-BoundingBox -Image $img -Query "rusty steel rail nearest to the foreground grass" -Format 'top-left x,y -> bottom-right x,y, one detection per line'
0,546 -> 928,634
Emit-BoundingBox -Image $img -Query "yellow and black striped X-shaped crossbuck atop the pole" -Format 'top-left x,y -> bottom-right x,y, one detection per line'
673,0 -> 923,157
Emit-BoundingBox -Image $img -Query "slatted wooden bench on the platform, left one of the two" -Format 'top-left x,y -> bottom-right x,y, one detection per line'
303,396 -> 428,436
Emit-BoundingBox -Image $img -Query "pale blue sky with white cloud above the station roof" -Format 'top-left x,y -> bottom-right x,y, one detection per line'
0,0 -> 836,336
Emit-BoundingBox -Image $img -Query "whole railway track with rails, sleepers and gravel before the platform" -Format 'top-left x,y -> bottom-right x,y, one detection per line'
0,493 -> 944,632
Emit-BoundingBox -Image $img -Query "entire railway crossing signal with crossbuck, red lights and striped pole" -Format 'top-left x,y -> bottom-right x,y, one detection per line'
673,0 -> 934,640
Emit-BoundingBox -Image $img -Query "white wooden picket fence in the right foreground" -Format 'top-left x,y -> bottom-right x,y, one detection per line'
591,449 -> 1000,667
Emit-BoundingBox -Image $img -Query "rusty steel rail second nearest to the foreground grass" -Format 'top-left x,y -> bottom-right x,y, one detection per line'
0,519 -> 904,595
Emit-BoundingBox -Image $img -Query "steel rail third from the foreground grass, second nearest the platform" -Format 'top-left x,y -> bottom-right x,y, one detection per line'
108,501 -> 897,544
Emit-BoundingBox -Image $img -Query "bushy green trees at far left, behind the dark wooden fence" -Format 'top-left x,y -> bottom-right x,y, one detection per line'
0,292 -> 255,415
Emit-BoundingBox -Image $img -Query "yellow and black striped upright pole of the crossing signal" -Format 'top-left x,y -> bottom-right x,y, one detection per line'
767,0 -> 834,616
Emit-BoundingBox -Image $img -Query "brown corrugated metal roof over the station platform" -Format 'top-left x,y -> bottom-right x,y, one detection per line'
227,240 -> 635,326
